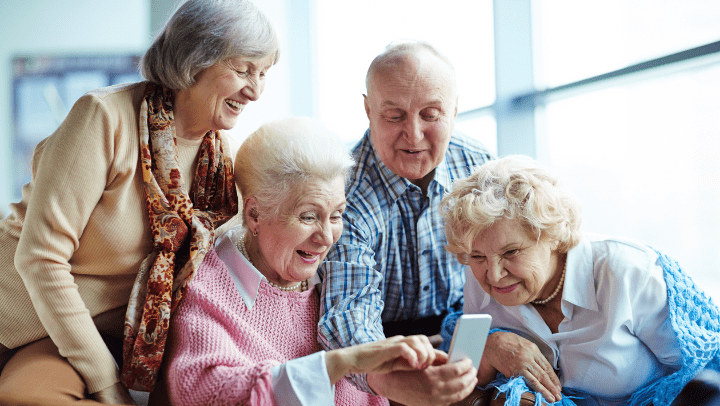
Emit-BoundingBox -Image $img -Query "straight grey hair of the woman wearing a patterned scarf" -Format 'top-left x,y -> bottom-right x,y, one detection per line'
140,0 -> 279,90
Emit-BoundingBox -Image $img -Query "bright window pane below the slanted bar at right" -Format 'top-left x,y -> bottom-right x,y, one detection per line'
542,63 -> 720,300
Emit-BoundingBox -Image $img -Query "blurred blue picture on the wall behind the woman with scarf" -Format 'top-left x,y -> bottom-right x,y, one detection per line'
12,54 -> 142,200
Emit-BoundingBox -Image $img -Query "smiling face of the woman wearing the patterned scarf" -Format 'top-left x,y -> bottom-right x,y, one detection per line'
175,55 -> 274,138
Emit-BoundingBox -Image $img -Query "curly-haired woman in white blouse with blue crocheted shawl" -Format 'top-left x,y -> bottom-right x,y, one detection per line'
441,157 -> 720,405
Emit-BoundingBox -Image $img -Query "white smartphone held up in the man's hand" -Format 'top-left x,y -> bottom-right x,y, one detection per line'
448,314 -> 492,369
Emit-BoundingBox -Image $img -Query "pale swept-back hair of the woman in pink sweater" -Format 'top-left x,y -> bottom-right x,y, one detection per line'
235,117 -> 355,224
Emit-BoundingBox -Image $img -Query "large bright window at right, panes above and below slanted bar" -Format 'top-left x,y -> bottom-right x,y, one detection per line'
532,0 -> 720,300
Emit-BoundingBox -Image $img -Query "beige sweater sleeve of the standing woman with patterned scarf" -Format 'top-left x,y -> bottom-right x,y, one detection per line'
15,95 -> 124,393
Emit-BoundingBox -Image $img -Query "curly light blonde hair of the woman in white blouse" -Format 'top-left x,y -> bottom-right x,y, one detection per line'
440,155 -> 582,263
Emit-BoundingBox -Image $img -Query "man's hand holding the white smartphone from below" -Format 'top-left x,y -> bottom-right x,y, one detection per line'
368,351 -> 477,406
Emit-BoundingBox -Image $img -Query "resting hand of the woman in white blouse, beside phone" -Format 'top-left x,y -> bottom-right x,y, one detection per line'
480,331 -> 562,402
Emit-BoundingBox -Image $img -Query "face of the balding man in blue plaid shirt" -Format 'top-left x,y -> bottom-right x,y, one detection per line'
365,53 -> 457,189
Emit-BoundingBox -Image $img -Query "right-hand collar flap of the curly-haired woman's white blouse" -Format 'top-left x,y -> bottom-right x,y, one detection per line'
563,237 -> 599,311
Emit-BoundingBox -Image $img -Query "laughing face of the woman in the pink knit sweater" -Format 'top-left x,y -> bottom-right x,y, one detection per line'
249,176 -> 345,286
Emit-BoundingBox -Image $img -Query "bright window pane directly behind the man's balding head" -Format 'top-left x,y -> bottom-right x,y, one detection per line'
316,0 -> 495,144
